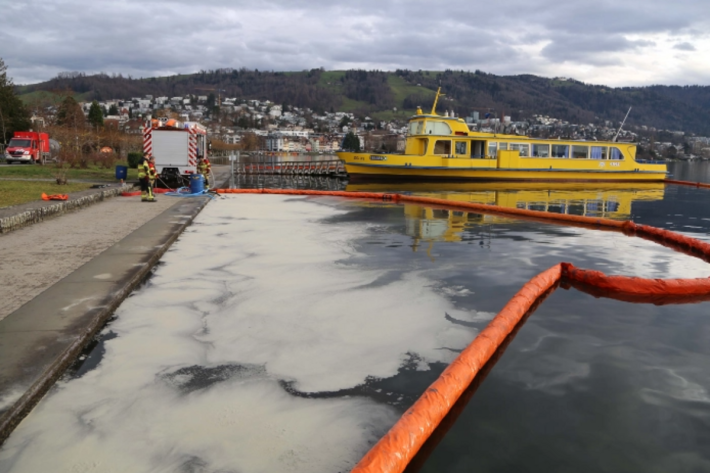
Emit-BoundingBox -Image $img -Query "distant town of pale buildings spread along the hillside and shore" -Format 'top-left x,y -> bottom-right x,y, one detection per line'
25,94 -> 710,160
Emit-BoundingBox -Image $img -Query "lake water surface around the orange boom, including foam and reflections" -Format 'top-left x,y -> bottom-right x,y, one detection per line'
0,163 -> 710,473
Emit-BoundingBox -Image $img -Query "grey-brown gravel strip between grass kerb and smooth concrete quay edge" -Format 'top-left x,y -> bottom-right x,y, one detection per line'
0,196 -> 180,320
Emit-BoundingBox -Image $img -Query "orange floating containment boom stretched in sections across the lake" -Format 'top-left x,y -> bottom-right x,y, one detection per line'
211,186 -> 710,473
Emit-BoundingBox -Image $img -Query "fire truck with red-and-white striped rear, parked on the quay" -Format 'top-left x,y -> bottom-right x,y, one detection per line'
143,119 -> 207,187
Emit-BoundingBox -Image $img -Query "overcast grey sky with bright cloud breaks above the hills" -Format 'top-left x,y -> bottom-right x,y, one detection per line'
0,0 -> 710,86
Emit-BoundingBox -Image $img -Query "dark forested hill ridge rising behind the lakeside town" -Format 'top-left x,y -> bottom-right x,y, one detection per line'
18,69 -> 710,136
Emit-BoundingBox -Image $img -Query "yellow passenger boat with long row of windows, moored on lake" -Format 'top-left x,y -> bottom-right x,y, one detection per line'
337,91 -> 667,181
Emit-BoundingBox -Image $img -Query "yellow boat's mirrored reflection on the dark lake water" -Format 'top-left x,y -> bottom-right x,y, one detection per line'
346,182 -> 665,242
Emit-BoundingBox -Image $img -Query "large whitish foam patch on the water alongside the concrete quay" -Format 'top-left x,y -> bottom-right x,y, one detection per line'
0,195 -> 493,473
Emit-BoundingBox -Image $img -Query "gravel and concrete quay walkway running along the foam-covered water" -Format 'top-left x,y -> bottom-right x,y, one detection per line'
0,166 -> 234,443
